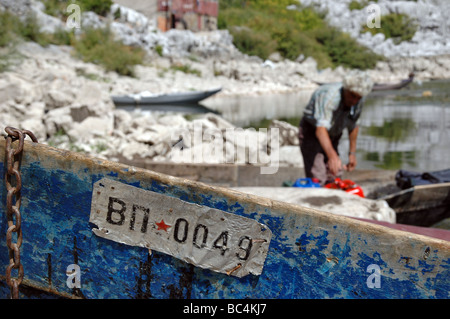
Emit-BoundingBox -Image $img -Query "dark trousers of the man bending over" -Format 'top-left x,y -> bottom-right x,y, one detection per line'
298,120 -> 341,185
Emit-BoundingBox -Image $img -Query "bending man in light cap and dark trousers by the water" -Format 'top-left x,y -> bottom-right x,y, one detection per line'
299,71 -> 373,185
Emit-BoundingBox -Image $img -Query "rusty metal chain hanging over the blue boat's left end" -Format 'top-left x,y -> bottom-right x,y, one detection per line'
5,127 -> 38,299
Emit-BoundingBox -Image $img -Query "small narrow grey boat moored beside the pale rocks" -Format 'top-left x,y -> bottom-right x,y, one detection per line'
111,88 -> 222,106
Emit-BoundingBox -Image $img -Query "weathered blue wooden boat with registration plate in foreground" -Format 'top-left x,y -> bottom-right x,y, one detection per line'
0,130 -> 450,299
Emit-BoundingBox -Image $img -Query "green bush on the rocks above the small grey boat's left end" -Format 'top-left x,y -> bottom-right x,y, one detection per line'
74,28 -> 144,76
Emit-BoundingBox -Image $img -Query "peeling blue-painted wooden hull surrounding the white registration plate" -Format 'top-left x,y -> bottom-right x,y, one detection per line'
0,141 -> 450,298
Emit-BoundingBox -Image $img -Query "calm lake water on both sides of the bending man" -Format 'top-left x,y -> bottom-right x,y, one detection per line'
202,80 -> 450,172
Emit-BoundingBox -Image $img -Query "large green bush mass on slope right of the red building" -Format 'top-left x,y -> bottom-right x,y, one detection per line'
218,0 -> 381,69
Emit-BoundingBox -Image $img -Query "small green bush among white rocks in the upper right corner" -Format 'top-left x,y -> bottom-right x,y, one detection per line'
362,13 -> 417,44
